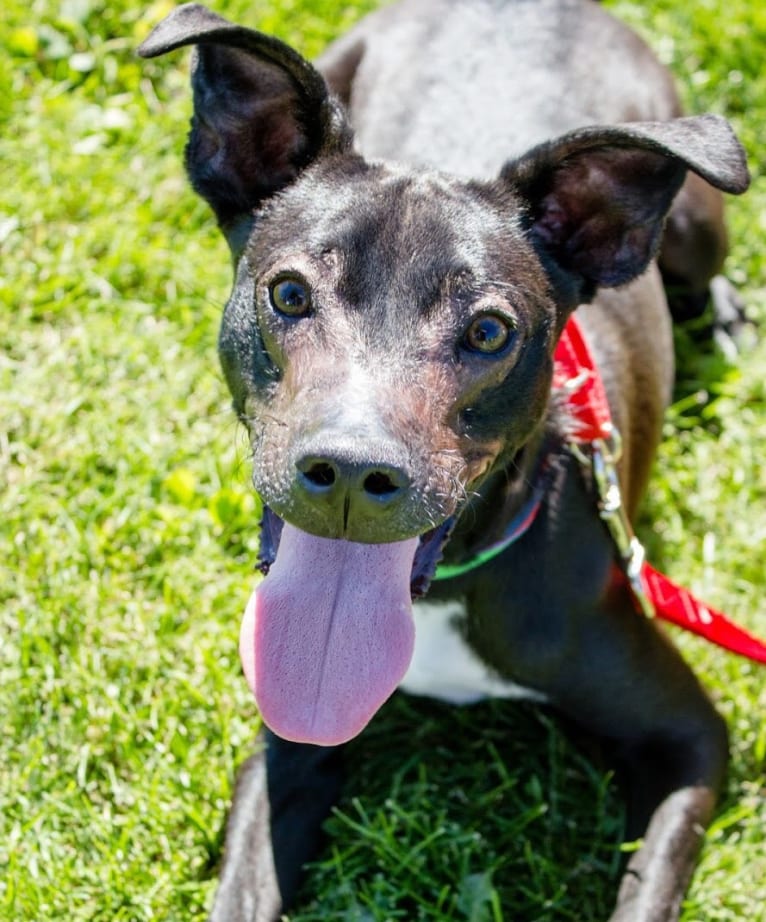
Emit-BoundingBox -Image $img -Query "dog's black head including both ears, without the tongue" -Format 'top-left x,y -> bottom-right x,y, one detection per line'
141,5 -> 746,739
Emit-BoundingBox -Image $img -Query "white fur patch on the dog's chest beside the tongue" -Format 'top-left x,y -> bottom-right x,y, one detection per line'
399,600 -> 545,704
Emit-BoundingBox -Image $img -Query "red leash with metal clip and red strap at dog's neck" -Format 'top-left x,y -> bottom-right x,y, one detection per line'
553,317 -> 766,663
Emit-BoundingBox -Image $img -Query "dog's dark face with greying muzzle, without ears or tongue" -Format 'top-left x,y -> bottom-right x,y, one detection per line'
220,156 -> 557,543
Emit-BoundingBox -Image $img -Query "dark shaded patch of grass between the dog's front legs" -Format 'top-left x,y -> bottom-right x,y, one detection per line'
290,694 -> 623,922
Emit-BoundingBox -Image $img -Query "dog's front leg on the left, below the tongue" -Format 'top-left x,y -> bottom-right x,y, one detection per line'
210,731 -> 342,922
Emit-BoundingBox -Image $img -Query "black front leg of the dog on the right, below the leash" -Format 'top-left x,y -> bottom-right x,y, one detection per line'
544,586 -> 728,922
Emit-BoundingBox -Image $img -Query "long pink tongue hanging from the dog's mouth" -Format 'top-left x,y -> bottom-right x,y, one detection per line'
239,523 -> 418,746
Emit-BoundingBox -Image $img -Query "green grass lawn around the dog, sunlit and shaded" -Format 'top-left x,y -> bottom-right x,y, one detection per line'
0,0 -> 766,922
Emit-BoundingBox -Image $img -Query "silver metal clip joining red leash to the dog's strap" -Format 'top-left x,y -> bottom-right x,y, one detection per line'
571,423 -> 655,618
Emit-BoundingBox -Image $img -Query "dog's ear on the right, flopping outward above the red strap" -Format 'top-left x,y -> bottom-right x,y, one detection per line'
501,115 -> 749,306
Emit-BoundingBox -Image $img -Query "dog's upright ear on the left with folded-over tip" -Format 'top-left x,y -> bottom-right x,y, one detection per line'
138,3 -> 352,253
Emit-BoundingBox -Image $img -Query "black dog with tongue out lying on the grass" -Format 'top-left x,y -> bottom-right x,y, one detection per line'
140,0 -> 748,922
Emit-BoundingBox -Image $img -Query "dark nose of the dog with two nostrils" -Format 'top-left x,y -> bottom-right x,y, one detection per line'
296,454 -> 410,515
